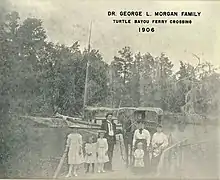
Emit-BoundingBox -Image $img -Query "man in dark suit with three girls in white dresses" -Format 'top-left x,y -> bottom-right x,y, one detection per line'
65,113 -> 116,177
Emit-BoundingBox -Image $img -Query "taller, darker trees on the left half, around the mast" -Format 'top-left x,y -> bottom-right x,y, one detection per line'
0,12 -> 108,176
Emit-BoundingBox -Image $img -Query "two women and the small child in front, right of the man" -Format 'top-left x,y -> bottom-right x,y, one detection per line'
132,120 -> 168,173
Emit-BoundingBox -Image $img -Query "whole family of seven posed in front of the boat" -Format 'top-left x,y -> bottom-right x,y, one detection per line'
65,113 -> 168,177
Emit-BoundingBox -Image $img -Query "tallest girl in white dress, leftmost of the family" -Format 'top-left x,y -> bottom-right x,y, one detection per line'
66,127 -> 84,177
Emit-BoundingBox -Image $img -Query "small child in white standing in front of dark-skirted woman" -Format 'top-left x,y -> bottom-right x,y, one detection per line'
134,142 -> 144,173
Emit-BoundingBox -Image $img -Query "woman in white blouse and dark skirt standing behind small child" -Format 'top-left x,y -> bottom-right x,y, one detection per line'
132,120 -> 151,172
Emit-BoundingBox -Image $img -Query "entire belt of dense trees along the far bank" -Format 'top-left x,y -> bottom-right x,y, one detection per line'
0,12 -> 220,177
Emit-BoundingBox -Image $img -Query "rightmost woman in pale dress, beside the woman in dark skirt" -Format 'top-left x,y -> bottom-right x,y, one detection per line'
151,125 -> 168,173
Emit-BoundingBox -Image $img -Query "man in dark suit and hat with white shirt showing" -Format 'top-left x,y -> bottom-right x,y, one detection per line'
101,113 -> 116,171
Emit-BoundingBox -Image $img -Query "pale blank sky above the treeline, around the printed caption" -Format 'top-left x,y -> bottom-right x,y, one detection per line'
7,0 -> 220,70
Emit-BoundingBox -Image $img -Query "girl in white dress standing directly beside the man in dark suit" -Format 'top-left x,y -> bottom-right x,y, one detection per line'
97,130 -> 109,173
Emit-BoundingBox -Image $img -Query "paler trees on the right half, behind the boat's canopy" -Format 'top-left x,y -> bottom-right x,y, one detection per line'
110,47 -> 220,114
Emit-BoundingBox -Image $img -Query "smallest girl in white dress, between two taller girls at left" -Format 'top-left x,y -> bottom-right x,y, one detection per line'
85,136 -> 96,173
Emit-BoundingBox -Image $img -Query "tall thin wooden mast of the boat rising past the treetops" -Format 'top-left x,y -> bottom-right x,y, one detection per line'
83,21 -> 92,119
